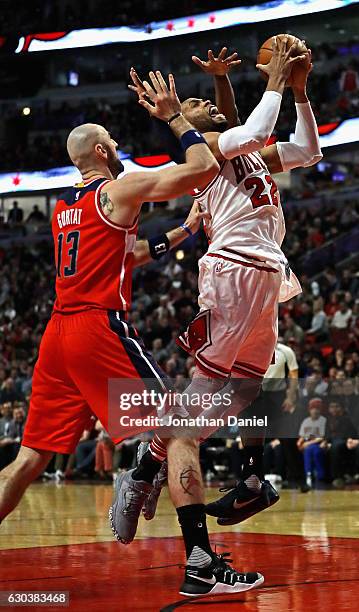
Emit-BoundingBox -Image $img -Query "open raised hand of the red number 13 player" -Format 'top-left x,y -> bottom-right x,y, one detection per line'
138,70 -> 181,121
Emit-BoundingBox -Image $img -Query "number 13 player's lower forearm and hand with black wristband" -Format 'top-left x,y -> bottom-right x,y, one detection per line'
134,202 -> 210,267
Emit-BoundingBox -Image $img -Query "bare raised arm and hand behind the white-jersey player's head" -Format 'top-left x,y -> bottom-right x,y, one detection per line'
192,47 -> 241,128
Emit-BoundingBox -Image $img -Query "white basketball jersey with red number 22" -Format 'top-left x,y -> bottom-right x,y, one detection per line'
195,152 -> 300,299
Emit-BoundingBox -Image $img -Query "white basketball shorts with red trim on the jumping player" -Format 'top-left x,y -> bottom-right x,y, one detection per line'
177,254 -> 281,378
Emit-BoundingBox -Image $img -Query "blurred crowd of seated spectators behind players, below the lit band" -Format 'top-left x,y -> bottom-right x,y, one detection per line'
0,203 -> 359,489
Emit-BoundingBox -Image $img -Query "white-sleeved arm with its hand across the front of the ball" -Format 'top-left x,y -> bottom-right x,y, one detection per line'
211,37 -> 305,159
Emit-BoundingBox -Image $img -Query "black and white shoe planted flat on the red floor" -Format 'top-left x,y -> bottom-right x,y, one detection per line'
180,552 -> 264,597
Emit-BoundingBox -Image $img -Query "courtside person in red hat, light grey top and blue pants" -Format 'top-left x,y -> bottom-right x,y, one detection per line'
297,398 -> 327,486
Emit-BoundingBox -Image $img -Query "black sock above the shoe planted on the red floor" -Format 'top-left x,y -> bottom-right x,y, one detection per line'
177,504 -> 212,559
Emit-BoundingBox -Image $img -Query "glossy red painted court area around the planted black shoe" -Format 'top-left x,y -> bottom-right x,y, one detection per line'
0,533 -> 359,612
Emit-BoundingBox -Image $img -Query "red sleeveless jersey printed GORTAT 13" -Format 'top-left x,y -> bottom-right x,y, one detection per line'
52,178 -> 138,312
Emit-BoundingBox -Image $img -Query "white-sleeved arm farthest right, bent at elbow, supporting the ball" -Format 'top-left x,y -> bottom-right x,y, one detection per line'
261,49 -> 323,172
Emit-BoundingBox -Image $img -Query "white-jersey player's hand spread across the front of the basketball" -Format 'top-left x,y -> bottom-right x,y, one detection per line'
256,36 -> 306,81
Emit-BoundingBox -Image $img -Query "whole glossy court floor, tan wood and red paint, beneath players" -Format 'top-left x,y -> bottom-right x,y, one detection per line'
0,483 -> 359,612
